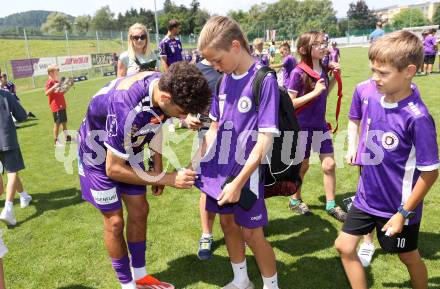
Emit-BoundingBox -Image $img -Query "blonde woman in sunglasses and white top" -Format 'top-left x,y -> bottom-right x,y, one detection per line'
118,23 -> 157,77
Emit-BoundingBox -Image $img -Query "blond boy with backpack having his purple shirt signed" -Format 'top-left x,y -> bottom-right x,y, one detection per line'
197,16 -> 279,289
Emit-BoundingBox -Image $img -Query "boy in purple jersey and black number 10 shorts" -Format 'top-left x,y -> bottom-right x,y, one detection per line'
335,31 -> 440,289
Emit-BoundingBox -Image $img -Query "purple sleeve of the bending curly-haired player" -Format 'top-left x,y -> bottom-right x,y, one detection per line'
105,102 -> 130,159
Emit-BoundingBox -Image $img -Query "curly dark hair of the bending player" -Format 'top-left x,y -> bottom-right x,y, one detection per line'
159,61 -> 211,114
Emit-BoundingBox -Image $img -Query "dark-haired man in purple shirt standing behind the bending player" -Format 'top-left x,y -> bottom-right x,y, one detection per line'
159,19 -> 183,71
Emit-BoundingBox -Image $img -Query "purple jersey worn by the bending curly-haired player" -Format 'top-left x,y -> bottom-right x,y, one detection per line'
79,72 -> 165,171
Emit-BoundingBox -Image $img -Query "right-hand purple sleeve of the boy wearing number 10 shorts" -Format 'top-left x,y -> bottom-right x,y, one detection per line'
410,115 -> 439,171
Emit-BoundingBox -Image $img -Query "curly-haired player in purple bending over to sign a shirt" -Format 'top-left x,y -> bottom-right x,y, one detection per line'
78,62 -> 211,289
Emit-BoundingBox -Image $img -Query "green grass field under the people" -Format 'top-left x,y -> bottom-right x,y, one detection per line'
0,48 -> 440,289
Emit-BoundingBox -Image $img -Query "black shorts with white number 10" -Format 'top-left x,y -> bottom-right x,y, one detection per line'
342,205 -> 420,253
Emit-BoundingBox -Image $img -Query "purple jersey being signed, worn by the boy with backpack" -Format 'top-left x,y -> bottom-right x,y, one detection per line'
196,64 -> 279,199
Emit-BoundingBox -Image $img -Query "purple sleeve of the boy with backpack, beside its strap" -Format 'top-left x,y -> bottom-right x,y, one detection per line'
258,74 -> 280,133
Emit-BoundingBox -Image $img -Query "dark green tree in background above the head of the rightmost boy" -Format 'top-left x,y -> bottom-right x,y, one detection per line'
347,0 -> 378,29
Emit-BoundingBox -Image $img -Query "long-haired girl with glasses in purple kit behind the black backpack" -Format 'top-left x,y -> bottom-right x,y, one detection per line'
288,31 -> 346,222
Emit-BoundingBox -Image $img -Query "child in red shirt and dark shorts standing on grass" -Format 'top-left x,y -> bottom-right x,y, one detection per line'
46,64 -> 71,146
